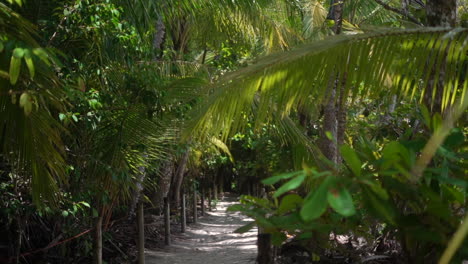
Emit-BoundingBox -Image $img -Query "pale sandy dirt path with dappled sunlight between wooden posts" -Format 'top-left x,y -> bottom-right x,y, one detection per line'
146,196 -> 257,264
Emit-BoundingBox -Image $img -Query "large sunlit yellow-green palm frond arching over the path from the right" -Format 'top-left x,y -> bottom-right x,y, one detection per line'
189,28 -> 468,146
